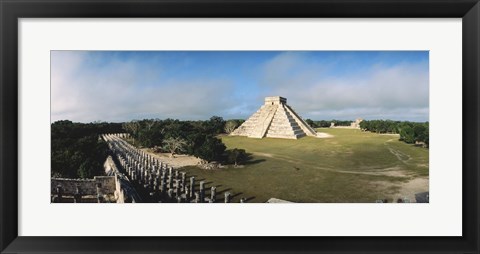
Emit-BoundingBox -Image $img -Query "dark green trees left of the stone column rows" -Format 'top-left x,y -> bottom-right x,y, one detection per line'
51,121 -> 122,178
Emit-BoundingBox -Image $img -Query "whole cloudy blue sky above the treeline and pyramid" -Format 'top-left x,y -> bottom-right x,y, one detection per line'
51,51 -> 429,122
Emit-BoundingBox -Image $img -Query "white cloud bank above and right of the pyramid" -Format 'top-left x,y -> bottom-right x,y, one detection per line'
262,53 -> 429,121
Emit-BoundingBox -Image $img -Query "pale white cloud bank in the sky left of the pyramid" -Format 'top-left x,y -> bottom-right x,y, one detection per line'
51,52 -> 232,122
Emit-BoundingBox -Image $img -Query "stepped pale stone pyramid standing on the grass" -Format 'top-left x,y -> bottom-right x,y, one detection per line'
230,96 -> 317,139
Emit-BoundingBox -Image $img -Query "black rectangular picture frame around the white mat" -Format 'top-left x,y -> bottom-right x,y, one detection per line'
0,0 -> 480,253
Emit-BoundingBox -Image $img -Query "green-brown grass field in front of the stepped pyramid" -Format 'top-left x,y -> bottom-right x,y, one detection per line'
180,128 -> 429,203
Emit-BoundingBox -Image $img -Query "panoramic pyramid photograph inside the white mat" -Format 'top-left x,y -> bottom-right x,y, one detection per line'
50,50 -> 430,205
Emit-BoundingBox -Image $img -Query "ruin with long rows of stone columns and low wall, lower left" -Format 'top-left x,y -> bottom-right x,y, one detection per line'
51,134 -> 253,203
